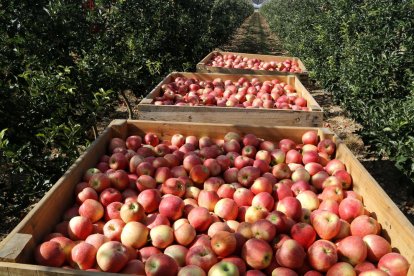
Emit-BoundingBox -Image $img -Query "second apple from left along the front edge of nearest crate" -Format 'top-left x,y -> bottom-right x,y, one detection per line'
70,241 -> 98,270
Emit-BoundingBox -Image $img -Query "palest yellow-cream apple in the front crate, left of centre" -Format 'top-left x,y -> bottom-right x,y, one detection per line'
121,221 -> 149,249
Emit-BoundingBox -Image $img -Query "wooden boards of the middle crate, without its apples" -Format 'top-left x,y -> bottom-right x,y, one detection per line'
138,72 -> 323,127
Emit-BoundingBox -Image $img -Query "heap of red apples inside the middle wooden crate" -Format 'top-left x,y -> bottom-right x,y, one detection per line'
153,77 -> 309,111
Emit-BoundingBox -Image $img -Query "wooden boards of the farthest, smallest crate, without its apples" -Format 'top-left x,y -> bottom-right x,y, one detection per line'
197,51 -> 309,84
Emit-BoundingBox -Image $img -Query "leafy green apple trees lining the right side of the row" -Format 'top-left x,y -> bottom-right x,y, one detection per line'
261,0 -> 414,183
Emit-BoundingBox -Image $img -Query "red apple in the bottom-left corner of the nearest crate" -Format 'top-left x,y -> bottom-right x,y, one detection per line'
34,240 -> 66,267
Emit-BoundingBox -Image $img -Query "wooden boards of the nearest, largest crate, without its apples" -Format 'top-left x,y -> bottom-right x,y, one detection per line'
0,120 -> 414,276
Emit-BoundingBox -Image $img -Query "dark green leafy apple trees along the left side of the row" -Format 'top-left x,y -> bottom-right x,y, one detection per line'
0,0 -> 253,211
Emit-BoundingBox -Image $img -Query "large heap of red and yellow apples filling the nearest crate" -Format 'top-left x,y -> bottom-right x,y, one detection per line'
34,130 -> 409,276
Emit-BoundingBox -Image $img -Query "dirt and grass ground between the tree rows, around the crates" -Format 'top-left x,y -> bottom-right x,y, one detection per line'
0,12 -> 414,243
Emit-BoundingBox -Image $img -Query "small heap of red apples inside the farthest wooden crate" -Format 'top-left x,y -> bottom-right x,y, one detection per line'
206,54 -> 302,73
